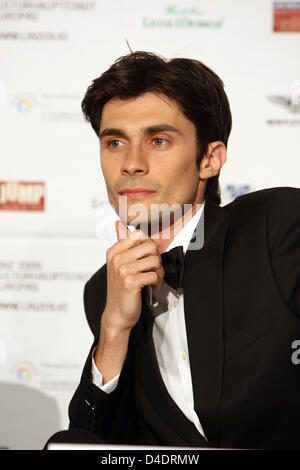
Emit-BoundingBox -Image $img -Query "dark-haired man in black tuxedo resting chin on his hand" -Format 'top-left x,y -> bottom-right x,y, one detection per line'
48,52 -> 300,448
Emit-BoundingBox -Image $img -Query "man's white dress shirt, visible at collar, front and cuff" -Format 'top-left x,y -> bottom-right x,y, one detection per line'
92,204 -> 205,437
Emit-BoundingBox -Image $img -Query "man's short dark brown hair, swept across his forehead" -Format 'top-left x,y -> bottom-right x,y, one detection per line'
82,51 -> 231,204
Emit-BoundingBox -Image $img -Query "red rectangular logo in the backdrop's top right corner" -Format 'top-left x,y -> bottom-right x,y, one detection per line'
273,1 -> 300,32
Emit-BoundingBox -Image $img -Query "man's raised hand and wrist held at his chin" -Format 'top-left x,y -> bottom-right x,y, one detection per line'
102,221 -> 165,331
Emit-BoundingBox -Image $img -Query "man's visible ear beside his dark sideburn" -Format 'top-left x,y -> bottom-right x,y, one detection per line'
199,141 -> 227,180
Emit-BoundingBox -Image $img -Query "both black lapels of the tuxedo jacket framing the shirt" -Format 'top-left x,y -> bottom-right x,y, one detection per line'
137,196 -> 229,446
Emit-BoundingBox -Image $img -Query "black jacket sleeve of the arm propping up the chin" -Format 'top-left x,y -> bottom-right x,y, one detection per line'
69,284 -> 137,444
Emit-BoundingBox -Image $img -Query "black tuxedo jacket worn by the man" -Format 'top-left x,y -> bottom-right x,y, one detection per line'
69,188 -> 300,449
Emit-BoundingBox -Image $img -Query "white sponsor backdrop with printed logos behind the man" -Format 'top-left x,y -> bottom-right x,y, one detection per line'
0,0 -> 300,449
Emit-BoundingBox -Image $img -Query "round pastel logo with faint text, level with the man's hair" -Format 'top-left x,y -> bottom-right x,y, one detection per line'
11,92 -> 84,123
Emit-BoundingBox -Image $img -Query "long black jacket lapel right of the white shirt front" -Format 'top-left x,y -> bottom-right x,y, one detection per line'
184,200 -> 229,445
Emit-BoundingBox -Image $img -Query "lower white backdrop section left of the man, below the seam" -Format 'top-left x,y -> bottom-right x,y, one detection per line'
0,237 -> 107,449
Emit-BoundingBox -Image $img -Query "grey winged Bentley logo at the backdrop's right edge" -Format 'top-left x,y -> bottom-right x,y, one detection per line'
267,80 -> 300,126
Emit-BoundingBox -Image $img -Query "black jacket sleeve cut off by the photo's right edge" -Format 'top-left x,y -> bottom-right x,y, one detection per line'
267,188 -> 300,318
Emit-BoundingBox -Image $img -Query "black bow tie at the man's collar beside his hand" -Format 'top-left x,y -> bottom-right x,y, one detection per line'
161,246 -> 184,289
